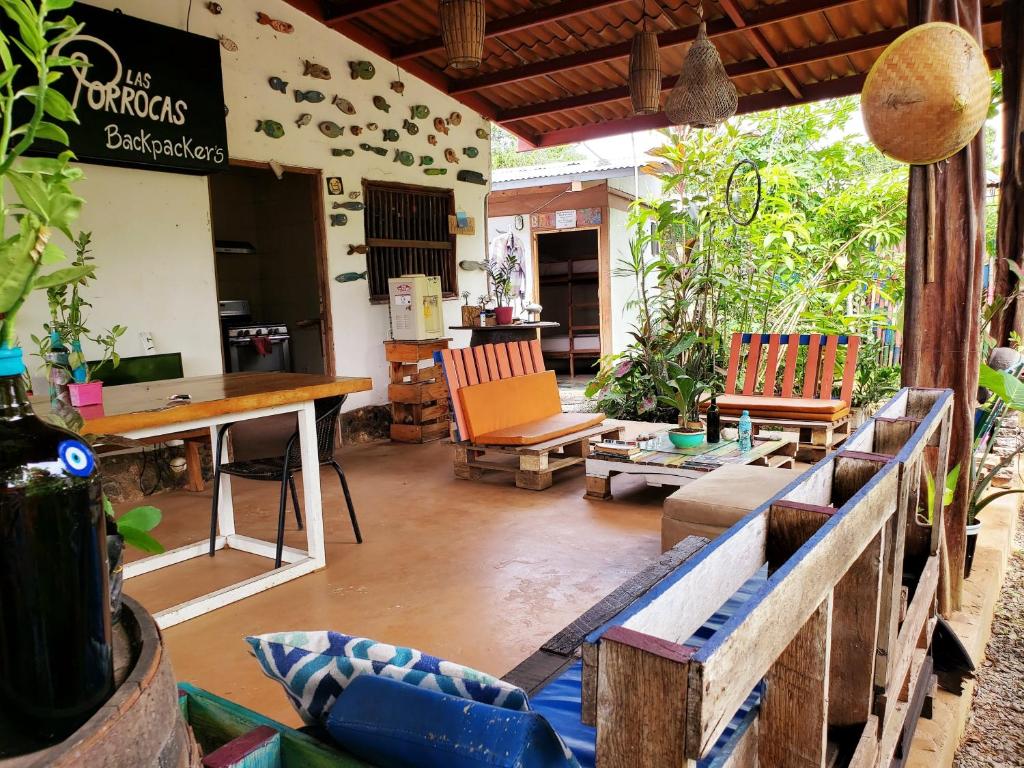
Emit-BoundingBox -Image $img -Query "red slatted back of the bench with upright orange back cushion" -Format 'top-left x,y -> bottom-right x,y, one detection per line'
436,339 -> 544,439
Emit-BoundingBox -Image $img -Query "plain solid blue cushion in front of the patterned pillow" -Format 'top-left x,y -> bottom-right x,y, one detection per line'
327,677 -> 579,768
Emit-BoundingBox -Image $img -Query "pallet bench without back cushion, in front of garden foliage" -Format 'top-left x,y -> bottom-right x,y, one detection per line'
705,333 -> 860,461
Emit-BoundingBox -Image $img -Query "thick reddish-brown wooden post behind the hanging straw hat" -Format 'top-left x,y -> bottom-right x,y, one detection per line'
903,0 -> 985,608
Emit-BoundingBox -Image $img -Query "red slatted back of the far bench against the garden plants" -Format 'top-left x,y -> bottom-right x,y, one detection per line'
725,333 -> 860,406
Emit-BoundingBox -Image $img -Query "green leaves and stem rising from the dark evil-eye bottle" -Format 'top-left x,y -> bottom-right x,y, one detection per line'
0,0 -> 92,347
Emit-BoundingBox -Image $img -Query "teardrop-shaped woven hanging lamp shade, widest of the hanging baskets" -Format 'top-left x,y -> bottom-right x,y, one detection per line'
665,20 -> 736,128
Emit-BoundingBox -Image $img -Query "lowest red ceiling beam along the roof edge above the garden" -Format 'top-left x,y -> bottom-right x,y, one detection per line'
534,75 -> 867,147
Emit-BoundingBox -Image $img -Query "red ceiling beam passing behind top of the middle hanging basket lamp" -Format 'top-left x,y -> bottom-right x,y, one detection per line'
449,0 -> 859,95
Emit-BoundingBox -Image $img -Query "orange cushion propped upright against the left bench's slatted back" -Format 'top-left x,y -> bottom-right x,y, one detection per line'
459,371 -> 562,442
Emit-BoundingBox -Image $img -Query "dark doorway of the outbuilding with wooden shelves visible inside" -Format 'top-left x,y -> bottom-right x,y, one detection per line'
536,228 -> 601,379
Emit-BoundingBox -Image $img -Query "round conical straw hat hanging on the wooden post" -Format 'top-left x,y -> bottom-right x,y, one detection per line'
860,22 -> 991,165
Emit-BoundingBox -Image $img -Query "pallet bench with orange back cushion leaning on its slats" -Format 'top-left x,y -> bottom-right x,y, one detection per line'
435,340 -> 622,490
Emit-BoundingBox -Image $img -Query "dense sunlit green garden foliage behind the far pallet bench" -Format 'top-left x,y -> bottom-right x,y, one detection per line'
588,99 -> 906,420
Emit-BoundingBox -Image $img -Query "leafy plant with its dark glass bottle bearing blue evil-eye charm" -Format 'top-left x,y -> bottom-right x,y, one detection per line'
0,0 -> 125,742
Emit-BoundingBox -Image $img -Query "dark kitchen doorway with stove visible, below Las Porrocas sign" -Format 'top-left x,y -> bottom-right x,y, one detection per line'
210,162 -> 334,375
